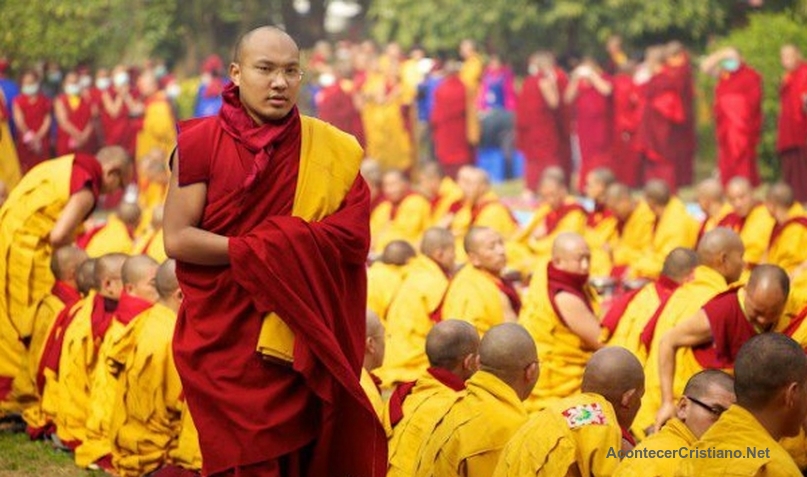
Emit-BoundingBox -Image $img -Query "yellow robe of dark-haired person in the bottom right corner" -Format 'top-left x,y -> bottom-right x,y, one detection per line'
675,405 -> 801,477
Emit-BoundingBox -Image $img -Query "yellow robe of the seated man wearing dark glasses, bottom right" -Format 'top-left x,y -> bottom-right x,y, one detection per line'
614,418 -> 698,477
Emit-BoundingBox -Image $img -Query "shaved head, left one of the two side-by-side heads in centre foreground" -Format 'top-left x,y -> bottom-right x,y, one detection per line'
426,320 -> 479,370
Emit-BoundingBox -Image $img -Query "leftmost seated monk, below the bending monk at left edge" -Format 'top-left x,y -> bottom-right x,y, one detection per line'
11,245 -> 87,428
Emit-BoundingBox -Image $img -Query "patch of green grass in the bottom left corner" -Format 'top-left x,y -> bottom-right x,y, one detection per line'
0,432 -> 103,477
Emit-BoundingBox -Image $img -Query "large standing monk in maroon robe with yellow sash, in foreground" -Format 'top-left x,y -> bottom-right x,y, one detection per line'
164,27 -> 387,477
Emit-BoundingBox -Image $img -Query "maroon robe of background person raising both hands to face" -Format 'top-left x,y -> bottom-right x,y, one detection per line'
573,74 -> 613,190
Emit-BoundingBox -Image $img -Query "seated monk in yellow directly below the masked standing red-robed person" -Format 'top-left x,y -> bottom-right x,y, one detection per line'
719,177 -> 776,268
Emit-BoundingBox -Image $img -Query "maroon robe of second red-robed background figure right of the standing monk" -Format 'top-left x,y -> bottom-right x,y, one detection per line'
516,73 -> 569,190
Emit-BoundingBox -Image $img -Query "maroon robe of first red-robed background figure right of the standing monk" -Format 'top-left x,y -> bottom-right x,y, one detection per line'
429,75 -> 472,166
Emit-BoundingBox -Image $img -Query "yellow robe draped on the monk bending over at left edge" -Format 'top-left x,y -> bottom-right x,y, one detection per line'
0,155 -> 73,411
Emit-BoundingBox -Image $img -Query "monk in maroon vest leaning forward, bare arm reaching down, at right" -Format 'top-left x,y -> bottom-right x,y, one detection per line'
656,265 -> 790,429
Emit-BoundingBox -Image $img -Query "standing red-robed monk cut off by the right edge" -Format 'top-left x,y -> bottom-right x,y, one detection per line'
776,45 -> 807,202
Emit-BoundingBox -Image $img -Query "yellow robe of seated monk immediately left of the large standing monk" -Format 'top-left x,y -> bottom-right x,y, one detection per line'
109,303 -> 184,477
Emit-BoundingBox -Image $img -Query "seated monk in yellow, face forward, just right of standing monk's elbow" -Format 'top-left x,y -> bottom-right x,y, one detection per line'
370,169 -> 431,252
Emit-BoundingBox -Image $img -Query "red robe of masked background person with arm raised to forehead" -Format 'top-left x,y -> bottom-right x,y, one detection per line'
714,64 -> 762,186
